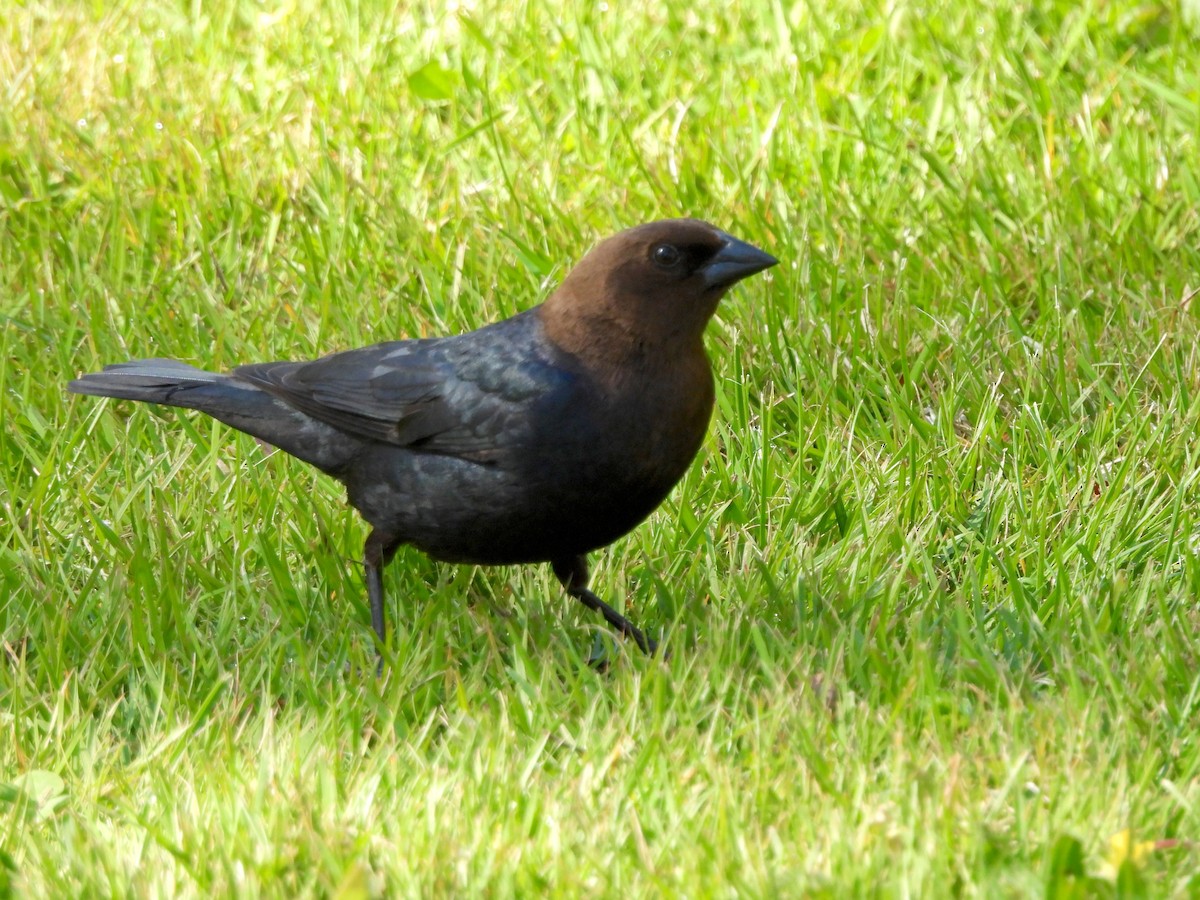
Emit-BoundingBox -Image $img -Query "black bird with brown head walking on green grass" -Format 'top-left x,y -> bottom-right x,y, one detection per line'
67,218 -> 779,667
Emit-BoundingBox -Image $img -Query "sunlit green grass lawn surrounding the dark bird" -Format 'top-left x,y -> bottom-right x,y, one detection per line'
0,0 -> 1200,898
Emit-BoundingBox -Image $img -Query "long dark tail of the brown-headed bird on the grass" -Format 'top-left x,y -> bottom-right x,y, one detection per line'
67,359 -> 362,475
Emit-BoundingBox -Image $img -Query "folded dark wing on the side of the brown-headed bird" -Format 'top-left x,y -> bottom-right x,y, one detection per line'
234,317 -> 571,461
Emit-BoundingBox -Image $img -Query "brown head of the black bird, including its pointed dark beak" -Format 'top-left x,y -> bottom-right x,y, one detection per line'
541,218 -> 779,364
